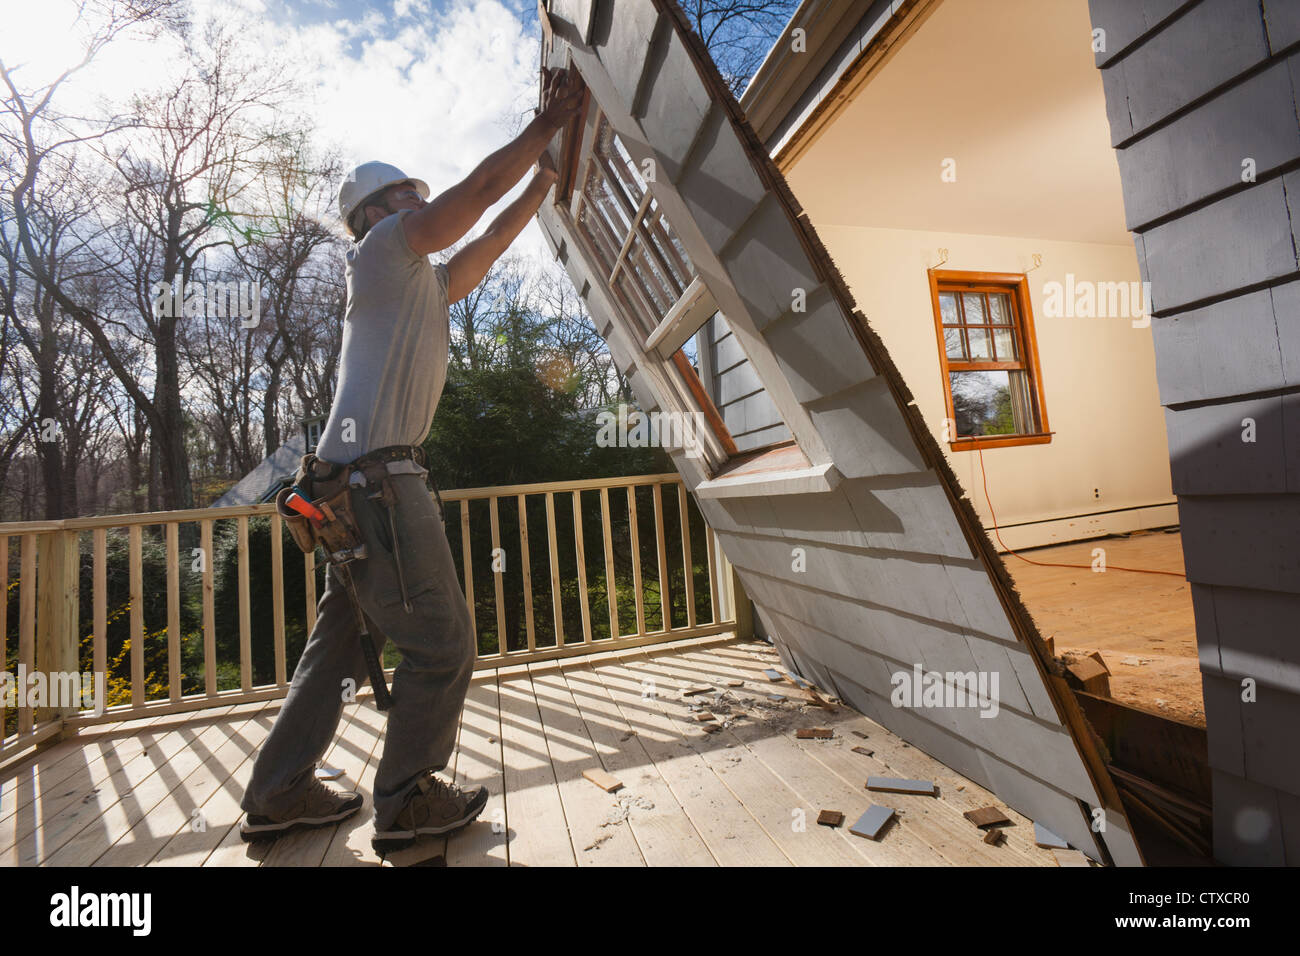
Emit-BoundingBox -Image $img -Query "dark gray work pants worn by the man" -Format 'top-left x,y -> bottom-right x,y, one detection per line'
242,475 -> 477,830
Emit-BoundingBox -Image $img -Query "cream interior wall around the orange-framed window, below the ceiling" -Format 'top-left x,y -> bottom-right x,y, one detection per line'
793,223 -> 1178,549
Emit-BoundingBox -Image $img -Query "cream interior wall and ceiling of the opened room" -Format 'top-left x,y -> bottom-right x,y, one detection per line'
783,0 -> 1178,550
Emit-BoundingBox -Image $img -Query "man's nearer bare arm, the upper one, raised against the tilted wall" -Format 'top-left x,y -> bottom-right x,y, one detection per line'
403,70 -> 582,257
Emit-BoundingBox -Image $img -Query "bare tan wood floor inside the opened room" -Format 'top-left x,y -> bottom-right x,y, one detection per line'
1002,531 -> 1205,727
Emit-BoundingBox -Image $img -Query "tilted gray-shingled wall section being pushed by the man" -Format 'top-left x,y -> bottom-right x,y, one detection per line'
538,0 -> 1141,865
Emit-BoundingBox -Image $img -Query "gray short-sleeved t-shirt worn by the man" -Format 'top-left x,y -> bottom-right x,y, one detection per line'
316,209 -> 451,463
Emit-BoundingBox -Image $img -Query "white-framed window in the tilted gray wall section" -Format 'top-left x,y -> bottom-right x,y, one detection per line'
571,111 -> 793,463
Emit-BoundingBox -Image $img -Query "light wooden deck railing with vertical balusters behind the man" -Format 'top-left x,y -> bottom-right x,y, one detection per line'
0,475 -> 736,765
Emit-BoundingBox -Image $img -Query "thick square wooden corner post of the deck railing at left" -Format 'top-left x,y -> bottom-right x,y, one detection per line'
36,531 -> 81,722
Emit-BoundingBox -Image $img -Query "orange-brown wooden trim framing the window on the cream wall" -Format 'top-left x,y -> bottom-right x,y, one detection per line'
928,269 -> 1052,451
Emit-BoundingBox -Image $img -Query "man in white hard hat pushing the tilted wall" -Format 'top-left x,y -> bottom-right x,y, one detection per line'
241,70 -> 581,853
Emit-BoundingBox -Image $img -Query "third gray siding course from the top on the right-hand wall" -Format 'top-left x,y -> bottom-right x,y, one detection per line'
1119,56 -> 1300,229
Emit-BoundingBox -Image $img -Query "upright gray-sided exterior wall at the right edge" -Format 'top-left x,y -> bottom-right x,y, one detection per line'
1091,0 -> 1300,866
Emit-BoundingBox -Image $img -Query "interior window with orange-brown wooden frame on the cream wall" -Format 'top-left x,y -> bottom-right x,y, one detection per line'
930,269 -> 1052,451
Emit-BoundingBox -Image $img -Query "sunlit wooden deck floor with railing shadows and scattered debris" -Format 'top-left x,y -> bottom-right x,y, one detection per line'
0,637 -> 1056,866
